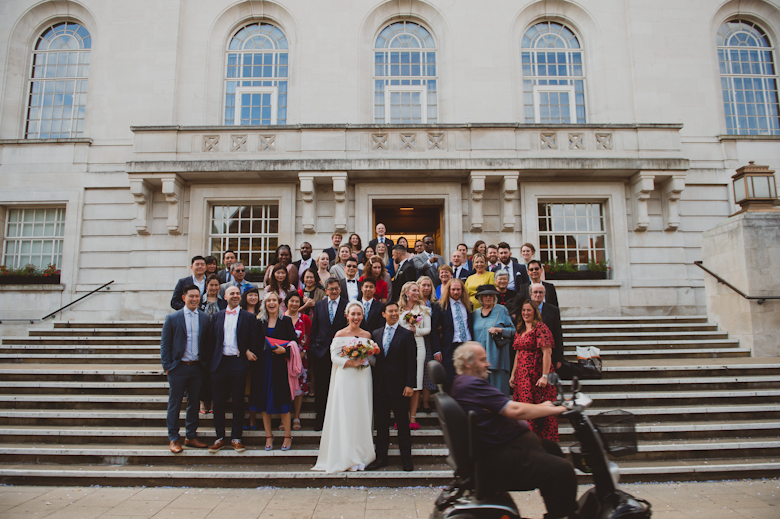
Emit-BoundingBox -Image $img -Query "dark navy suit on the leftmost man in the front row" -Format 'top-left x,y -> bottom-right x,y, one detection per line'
160,309 -> 209,441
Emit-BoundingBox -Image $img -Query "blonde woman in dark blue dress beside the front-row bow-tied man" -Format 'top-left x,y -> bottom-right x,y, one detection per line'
249,292 -> 298,451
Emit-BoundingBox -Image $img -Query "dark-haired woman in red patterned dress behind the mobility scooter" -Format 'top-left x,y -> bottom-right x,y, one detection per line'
509,300 -> 558,442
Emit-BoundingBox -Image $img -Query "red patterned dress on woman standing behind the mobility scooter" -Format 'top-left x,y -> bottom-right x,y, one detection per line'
513,323 -> 558,442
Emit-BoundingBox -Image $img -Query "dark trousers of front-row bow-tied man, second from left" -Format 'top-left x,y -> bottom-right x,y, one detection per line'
211,357 -> 247,440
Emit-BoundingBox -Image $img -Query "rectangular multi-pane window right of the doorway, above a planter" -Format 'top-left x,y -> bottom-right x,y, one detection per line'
539,202 -> 607,265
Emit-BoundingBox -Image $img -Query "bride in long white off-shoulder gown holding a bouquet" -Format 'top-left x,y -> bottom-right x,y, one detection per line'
312,301 -> 376,473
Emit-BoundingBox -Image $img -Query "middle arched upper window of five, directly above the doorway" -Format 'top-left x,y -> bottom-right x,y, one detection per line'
374,22 -> 438,124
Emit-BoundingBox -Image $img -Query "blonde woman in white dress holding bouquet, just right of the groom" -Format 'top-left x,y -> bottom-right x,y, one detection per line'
398,281 -> 431,431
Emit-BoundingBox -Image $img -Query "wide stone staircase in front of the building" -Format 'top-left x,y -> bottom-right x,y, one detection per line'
0,317 -> 780,487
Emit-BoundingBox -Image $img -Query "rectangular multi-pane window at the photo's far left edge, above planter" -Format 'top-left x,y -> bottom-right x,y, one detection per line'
3,207 -> 65,269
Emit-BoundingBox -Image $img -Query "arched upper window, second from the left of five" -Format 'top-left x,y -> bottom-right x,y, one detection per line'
225,23 -> 289,125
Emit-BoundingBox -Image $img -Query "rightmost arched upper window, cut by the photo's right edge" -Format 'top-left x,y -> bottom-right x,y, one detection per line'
717,20 -> 780,135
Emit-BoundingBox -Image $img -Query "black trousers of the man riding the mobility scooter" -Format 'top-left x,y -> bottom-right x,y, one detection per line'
478,431 -> 577,519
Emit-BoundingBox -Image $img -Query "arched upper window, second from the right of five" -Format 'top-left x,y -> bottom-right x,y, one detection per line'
520,22 -> 585,124
